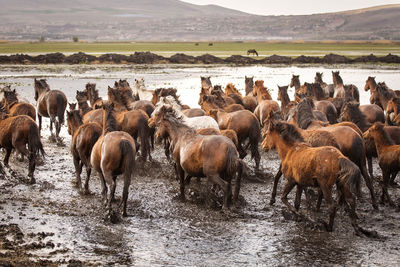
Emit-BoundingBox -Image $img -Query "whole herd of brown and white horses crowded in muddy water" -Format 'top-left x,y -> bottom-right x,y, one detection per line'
0,71 -> 400,237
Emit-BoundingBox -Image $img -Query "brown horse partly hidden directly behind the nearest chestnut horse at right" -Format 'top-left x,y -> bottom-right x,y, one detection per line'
293,98 -> 377,208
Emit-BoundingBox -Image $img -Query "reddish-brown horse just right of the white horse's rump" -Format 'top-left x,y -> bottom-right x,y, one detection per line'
207,109 -> 261,170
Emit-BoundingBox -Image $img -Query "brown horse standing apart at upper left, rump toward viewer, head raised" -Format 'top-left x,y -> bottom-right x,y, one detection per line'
35,78 -> 68,139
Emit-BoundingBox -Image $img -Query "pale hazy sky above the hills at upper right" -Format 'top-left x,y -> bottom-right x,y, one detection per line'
183,0 -> 400,15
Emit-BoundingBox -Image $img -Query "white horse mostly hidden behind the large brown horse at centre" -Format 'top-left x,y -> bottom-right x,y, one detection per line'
152,96 -> 219,130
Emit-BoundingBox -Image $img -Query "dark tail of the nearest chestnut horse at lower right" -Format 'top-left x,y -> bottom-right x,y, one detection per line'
338,157 -> 361,200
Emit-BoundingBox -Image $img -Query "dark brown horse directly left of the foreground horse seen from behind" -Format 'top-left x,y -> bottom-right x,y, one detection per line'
67,110 -> 103,194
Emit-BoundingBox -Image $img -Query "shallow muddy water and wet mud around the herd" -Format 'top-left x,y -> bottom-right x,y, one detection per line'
0,66 -> 400,266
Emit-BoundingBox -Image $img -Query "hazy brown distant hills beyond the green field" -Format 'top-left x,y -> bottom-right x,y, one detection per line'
0,0 -> 400,41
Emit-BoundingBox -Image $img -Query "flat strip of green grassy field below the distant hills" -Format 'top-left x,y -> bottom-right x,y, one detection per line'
0,41 -> 400,57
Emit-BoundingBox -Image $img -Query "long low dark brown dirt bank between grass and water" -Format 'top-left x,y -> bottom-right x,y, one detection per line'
0,52 -> 400,65
